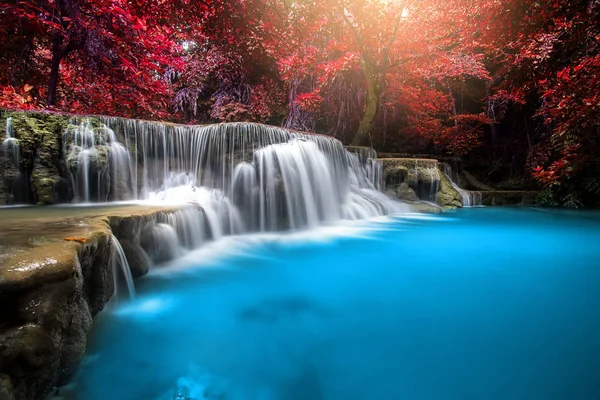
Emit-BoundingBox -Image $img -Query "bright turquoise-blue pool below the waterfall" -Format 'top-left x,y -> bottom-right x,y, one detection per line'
74,209 -> 600,400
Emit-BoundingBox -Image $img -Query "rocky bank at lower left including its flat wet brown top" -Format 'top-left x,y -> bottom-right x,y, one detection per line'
0,206 -> 185,400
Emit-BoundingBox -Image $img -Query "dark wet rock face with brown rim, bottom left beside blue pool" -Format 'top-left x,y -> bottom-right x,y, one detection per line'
0,226 -> 114,400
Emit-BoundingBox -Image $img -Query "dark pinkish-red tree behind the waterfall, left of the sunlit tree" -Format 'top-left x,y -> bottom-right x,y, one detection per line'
162,0 -> 284,122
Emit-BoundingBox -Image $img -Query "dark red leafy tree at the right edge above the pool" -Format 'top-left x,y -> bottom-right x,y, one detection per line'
483,0 -> 600,206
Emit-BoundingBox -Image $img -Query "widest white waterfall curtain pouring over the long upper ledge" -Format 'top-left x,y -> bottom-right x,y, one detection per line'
65,118 -> 408,231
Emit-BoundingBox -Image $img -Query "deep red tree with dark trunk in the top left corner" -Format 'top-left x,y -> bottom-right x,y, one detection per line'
0,0 -> 177,117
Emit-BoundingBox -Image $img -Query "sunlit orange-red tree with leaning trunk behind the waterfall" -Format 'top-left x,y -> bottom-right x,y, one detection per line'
272,0 -> 488,151
